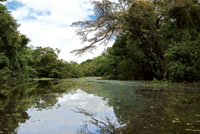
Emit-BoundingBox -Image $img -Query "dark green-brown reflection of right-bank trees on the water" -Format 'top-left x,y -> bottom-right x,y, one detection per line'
72,79 -> 200,134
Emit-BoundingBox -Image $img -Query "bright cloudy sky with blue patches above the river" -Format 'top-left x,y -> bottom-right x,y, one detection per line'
5,0 -> 112,63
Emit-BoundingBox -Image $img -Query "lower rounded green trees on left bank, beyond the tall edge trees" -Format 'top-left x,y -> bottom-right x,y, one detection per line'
31,47 -> 81,78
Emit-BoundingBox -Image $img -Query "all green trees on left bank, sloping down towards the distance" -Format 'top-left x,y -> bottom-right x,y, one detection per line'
0,4 -> 82,81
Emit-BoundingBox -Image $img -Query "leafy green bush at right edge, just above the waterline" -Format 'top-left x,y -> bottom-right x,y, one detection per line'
165,31 -> 200,80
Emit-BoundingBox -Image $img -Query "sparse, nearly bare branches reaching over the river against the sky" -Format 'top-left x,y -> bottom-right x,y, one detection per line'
72,0 -> 129,54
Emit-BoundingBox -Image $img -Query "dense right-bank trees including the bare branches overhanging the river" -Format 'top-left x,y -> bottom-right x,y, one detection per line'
73,0 -> 200,81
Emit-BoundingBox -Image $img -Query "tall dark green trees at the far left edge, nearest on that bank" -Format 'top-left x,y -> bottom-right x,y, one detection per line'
0,4 -> 34,80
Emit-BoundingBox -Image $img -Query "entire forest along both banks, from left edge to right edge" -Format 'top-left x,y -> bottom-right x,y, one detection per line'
0,0 -> 200,81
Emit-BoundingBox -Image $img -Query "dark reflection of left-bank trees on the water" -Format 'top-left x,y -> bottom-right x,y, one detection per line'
0,81 -> 78,134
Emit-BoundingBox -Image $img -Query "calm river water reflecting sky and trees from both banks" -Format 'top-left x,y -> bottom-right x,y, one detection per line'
0,78 -> 200,134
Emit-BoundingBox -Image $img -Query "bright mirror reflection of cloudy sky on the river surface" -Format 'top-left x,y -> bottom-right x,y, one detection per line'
18,89 -> 113,134
